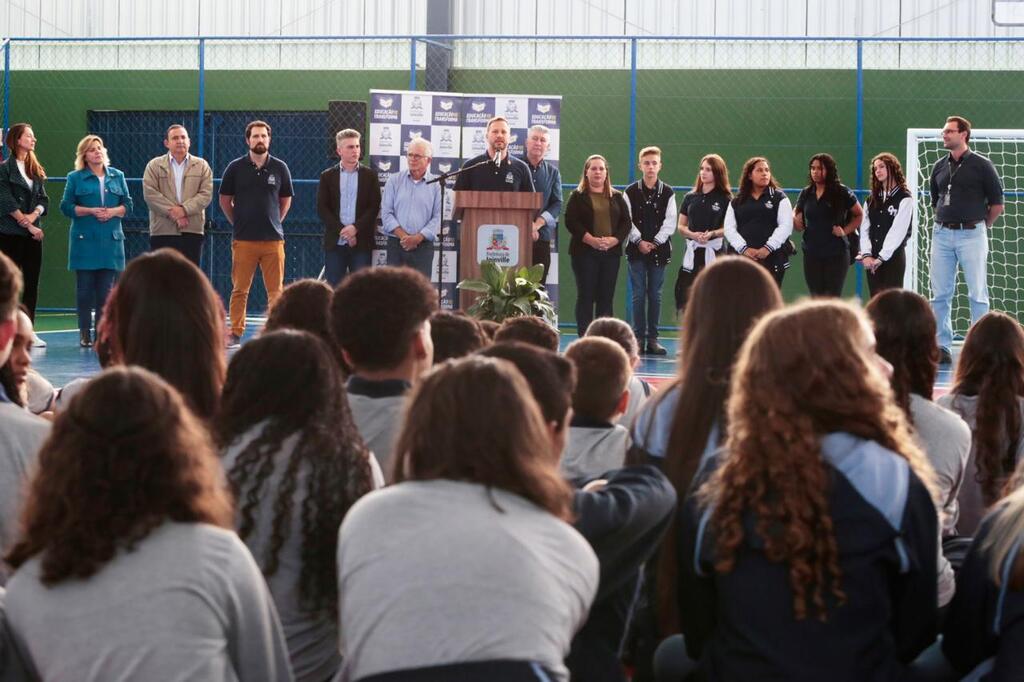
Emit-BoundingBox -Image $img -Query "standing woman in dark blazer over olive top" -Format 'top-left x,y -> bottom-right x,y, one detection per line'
565,154 -> 632,336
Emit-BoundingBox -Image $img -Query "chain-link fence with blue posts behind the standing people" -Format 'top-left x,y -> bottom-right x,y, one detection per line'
0,36 -> 1024,325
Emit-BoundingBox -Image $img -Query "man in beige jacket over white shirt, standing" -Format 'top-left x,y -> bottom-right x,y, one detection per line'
142,124 -> 213,267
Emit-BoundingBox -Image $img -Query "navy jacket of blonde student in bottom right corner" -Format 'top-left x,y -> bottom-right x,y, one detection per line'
942,509 -> 1024,682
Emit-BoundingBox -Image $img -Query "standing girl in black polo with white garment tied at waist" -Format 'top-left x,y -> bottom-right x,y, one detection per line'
676,154 -> 732,314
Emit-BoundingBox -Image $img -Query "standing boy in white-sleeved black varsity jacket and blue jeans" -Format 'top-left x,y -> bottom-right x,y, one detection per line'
623,146 -> 677,355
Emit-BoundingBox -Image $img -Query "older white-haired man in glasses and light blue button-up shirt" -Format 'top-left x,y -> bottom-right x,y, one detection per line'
381,137 -> 441,280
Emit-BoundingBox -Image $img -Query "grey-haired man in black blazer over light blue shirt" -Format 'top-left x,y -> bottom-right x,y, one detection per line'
316,128 -> 381,287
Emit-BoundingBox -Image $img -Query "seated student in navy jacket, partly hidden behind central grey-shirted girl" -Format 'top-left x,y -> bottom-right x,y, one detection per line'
480,339 -> 676,682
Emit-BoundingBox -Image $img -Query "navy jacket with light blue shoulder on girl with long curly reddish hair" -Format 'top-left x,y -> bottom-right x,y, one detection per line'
678,433 -> 939,682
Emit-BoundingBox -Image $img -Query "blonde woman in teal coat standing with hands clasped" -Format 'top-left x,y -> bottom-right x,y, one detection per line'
60,135 -> 132,348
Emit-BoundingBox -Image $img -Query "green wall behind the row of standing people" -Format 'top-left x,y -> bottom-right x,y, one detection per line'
10,70 -> 1024,325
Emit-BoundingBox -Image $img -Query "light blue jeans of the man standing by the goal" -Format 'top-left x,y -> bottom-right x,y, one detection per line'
930,222 -> 988,348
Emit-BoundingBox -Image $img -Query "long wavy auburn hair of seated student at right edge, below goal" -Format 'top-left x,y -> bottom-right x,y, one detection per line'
938,312 -> 1024,536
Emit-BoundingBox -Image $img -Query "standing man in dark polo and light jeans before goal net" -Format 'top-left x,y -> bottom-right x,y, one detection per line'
930,116 -> 1002,365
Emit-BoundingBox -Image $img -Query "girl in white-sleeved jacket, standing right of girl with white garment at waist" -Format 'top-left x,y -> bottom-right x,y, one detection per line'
724,157 -> 793,287
